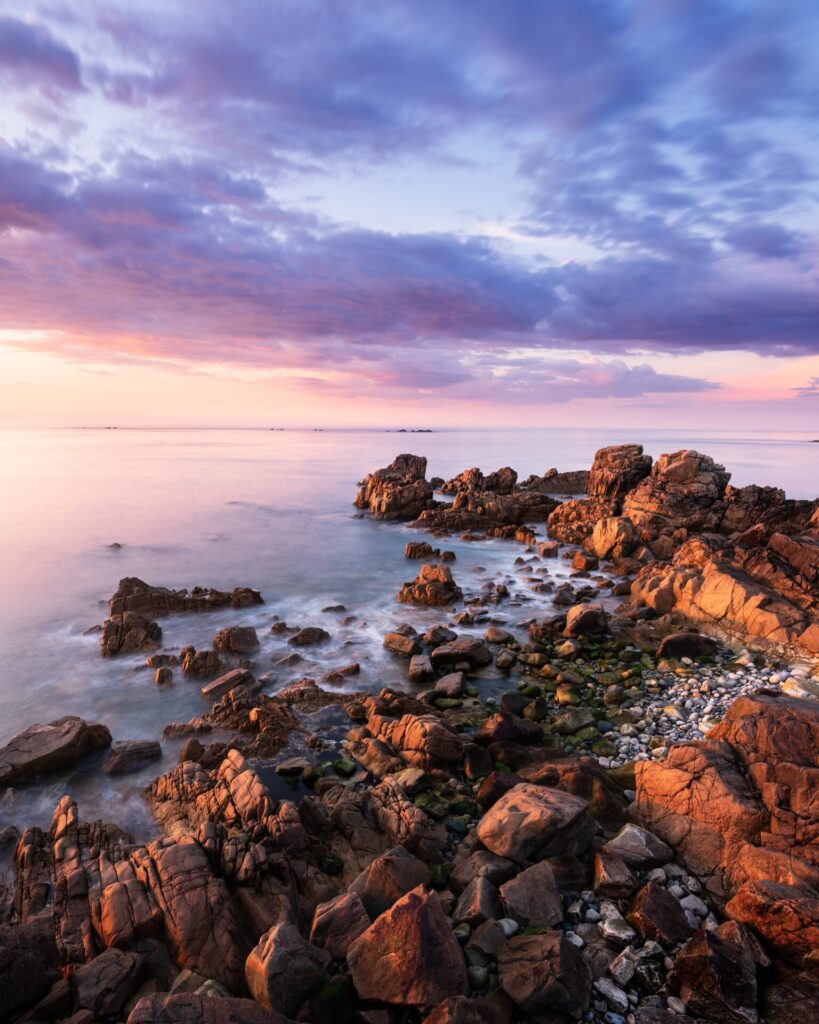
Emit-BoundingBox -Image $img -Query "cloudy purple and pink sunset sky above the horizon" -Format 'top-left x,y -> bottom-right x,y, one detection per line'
0,0 -> 819,431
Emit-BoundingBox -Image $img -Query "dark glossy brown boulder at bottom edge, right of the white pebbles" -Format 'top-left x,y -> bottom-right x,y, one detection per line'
669,929 -> 758,1024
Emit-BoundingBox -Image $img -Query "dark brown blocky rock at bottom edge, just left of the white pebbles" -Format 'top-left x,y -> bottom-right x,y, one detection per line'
498,932 -> 592,1020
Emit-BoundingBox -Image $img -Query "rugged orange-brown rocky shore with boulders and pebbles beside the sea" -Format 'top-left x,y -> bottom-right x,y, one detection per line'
0,444 -> 819,1024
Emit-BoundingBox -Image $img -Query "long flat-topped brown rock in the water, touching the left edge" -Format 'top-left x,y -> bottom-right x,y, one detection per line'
0,715 -> 111,785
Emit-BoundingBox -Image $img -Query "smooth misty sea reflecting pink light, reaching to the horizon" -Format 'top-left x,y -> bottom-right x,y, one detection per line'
0,429 -> 819,836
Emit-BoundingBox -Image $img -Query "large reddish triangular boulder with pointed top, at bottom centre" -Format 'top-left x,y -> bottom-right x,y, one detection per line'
347,886 -> 467,1007
